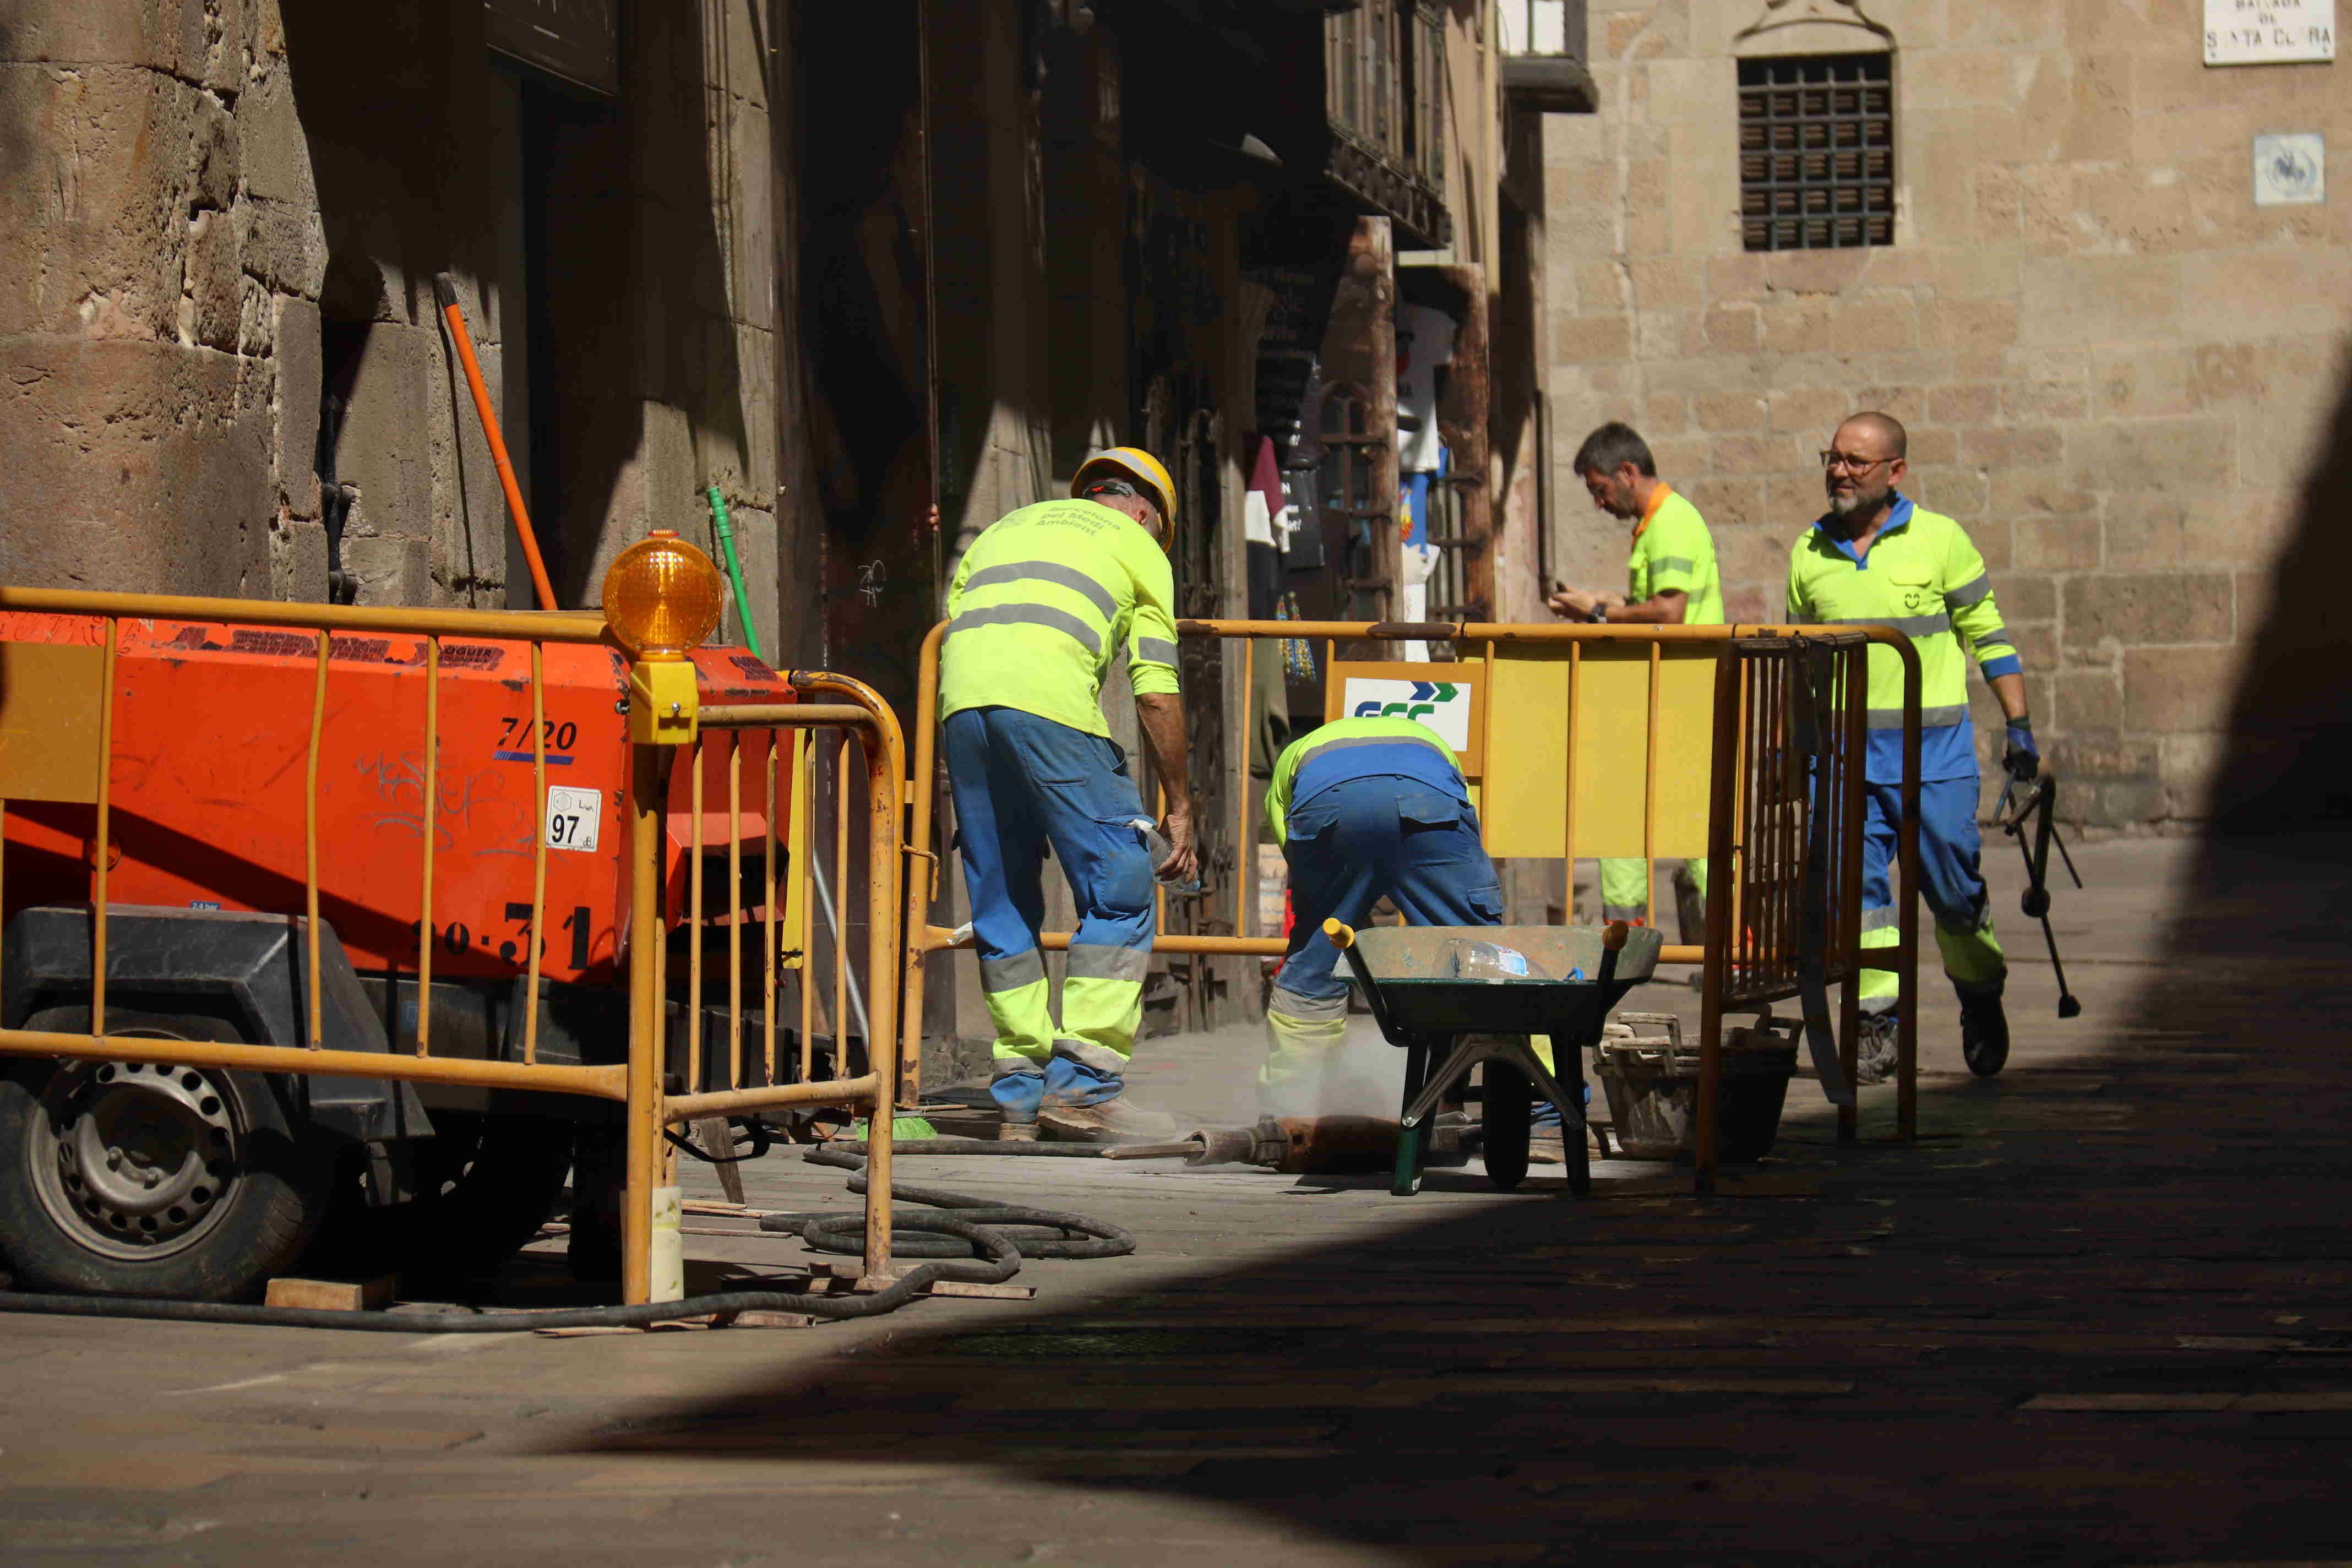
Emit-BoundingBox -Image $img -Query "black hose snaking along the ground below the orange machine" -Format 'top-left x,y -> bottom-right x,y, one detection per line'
0,1150 -> 1136,1333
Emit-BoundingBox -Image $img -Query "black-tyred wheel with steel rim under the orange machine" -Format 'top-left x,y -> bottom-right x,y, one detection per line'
0,1009 -> 329,1300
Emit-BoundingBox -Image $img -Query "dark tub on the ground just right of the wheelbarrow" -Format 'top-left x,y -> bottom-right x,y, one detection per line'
1592,1013 -> 1797,1164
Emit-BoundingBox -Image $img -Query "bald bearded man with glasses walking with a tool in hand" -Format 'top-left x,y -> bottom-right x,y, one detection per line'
1788,413 -> 2039,1084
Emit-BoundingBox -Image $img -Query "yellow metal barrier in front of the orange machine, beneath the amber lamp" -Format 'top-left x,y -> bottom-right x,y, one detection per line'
0,587 -> 906,1303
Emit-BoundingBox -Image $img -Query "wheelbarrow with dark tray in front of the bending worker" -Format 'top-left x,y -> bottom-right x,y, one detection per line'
1324,919 -> 1665,1196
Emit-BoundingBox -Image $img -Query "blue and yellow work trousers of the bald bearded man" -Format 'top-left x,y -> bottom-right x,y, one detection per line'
1863,778 -> 2008,1013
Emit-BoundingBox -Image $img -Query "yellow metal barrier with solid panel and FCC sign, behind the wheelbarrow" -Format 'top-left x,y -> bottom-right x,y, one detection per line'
901,620 -> 1919,1187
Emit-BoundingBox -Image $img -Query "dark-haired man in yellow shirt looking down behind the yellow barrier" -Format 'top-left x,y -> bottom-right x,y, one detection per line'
1545,421 -> 1724,943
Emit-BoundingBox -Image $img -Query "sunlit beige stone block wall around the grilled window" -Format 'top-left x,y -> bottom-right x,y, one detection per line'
1545,0 -> 2352,825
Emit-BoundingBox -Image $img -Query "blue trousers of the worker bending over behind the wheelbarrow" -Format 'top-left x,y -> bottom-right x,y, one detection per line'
1275,774 -> 1503,1006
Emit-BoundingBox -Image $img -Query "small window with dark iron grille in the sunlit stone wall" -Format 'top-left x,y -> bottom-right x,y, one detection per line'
1740,54 -> 1896,252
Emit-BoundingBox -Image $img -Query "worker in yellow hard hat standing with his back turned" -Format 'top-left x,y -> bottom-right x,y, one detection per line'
939,447 -> 1195,1142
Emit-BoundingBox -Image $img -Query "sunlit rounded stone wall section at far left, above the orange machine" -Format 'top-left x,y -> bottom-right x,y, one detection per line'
0,0 -> 325,597
